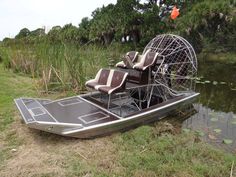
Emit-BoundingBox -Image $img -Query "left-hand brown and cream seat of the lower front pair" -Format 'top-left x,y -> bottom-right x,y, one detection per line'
85,69 -> 110,90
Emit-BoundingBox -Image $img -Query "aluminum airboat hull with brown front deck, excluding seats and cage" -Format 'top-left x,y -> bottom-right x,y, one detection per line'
15,93 -> 199,138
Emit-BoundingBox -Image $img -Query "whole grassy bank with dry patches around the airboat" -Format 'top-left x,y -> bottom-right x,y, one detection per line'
0,64 -> 236,177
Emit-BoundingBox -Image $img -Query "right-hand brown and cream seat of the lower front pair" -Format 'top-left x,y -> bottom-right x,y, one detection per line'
98,70 -> 128,95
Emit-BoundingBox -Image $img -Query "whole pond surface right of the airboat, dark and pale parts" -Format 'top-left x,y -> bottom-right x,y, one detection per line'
182,58 -> 236,152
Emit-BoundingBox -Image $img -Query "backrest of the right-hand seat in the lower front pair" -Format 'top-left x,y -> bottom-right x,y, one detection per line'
110,70 -> 128,87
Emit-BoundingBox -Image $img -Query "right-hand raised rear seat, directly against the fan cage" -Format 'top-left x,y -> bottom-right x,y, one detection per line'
133,51 -> 158,71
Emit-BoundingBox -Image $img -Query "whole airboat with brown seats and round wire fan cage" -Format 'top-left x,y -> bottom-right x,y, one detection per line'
15,34 -> 199,138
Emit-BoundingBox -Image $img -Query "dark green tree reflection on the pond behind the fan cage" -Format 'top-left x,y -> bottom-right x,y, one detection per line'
196,61 -> 236,113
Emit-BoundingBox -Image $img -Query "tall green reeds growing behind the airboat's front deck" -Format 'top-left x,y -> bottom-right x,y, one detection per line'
1,39 -> 127,92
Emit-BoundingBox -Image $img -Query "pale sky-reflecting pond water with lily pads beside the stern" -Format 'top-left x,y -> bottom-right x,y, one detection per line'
182,104 -> 236,151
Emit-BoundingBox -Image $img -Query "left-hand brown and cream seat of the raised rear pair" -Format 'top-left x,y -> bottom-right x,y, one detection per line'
116,51 -> 138,68
